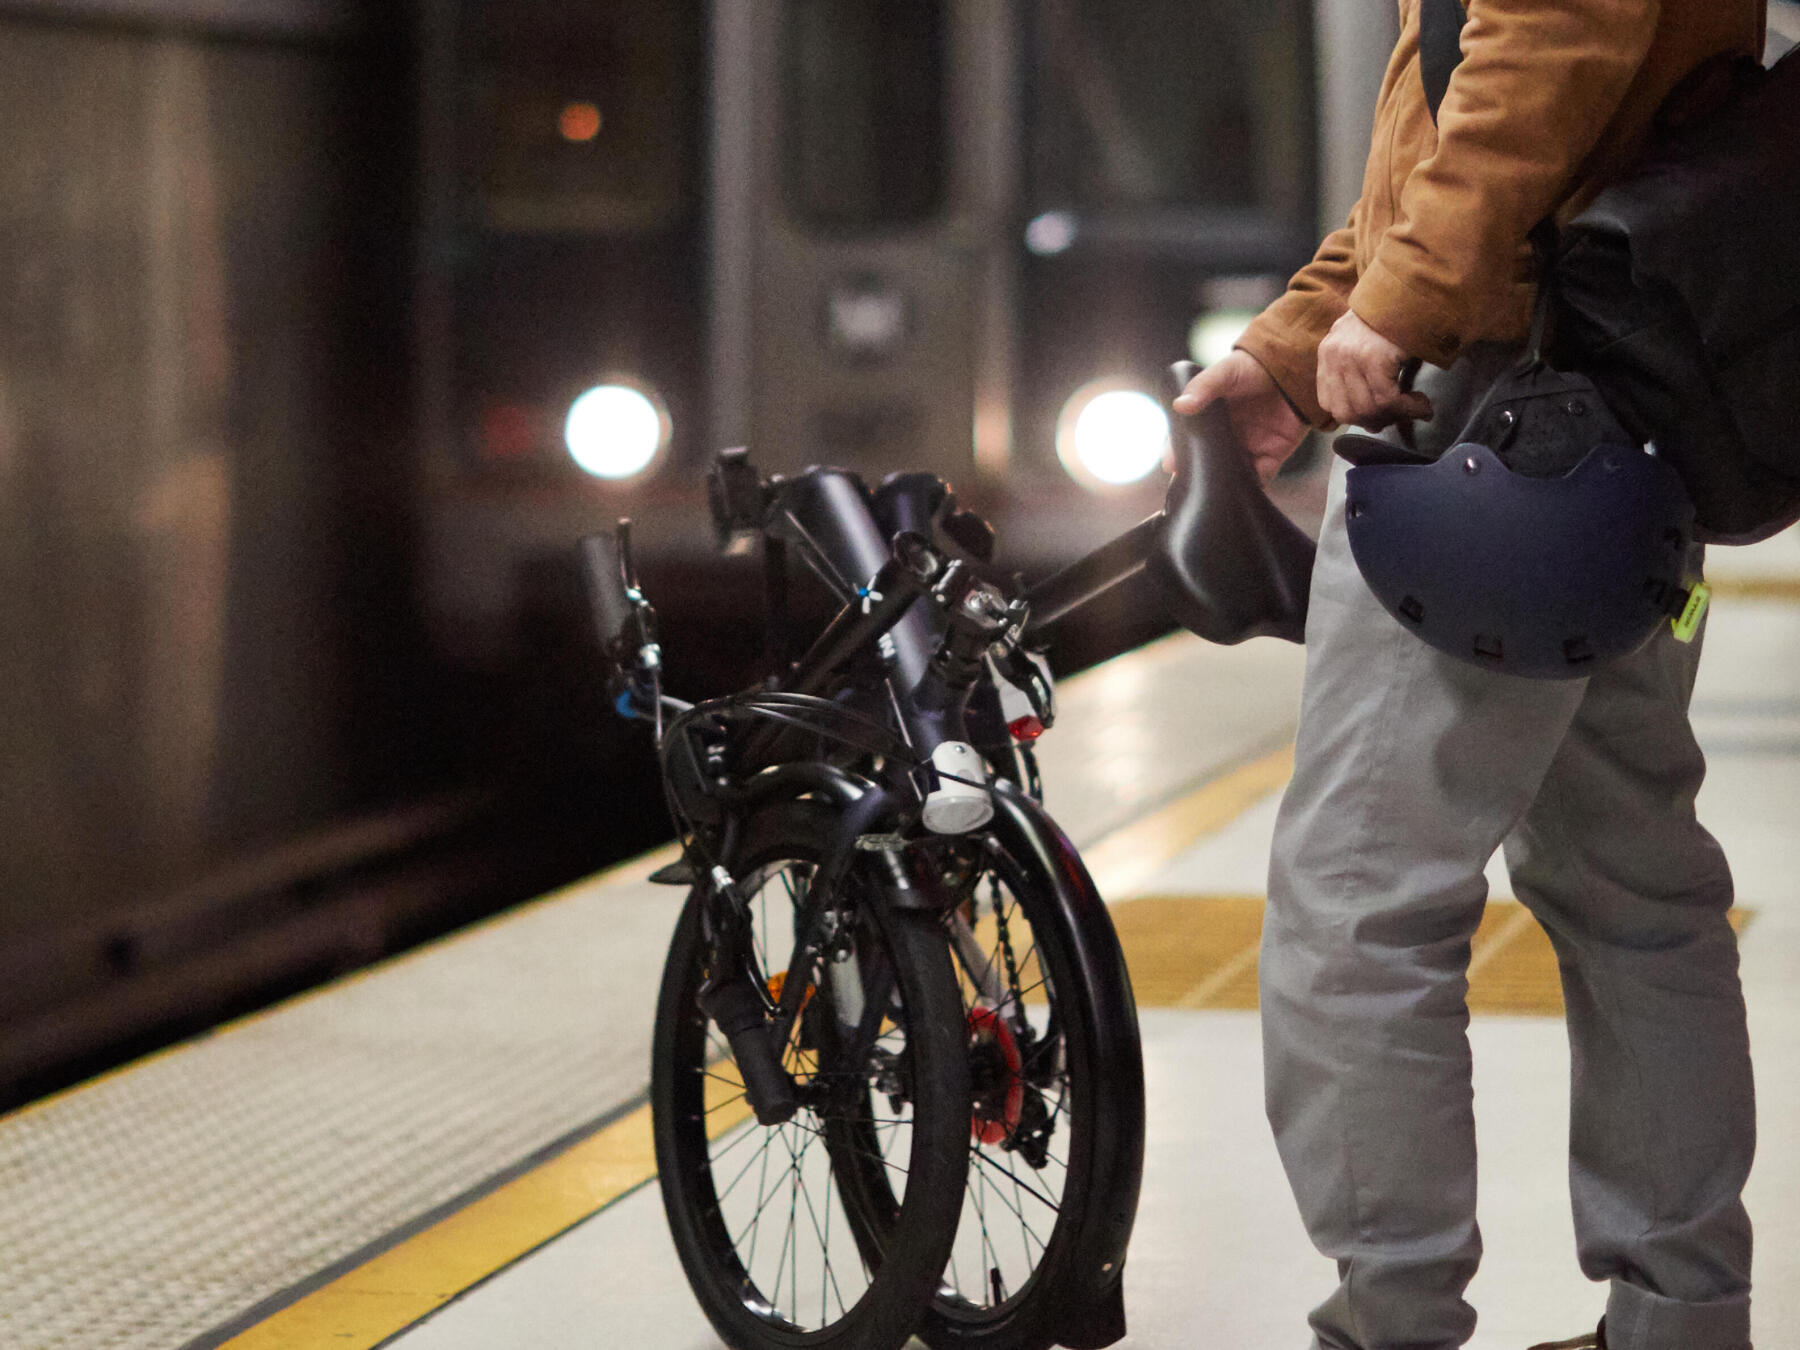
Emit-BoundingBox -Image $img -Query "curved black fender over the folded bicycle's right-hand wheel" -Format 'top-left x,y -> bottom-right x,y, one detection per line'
988,781 -> 1145,1350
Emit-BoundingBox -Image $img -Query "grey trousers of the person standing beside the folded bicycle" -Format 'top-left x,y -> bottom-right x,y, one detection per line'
1262,463 -> 1755,1350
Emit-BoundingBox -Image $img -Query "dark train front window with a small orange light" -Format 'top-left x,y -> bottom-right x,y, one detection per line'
472,0 -> 702,234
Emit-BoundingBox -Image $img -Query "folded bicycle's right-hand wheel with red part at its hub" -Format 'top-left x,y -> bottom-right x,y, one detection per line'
920,810 -> 1143,1350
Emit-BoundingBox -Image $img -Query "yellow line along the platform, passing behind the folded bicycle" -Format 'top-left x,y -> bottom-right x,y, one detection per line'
204,747 -> 1294,1350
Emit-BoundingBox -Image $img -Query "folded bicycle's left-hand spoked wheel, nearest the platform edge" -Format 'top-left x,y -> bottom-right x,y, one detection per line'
652,803 -> 970,1350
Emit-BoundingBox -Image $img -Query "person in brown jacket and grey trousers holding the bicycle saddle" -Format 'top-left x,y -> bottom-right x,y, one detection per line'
1175,0 -> 1764,1350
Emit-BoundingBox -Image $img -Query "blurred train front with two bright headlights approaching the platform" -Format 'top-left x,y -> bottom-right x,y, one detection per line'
418,0 -> 1393,664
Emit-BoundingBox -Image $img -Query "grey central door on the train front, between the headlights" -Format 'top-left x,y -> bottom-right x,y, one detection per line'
711,0 -> 1013,479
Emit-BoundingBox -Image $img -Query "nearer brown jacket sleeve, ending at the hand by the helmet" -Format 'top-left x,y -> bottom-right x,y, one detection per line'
1350,0 -> 1660,365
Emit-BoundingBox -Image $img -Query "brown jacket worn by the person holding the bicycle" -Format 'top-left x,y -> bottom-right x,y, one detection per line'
1238,0 -> 1766,427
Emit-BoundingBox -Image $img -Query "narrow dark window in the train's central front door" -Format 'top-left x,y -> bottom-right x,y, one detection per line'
781,0 -> 949,234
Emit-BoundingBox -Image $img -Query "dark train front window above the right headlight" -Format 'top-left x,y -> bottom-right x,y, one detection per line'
1028,0 -> 1314,218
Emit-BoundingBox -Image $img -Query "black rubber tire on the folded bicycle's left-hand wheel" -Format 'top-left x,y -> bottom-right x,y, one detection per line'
650,801 -> 970,1350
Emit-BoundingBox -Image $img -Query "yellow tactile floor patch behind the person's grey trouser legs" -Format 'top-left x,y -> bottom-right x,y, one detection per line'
1112,895 -> 1755,1017
